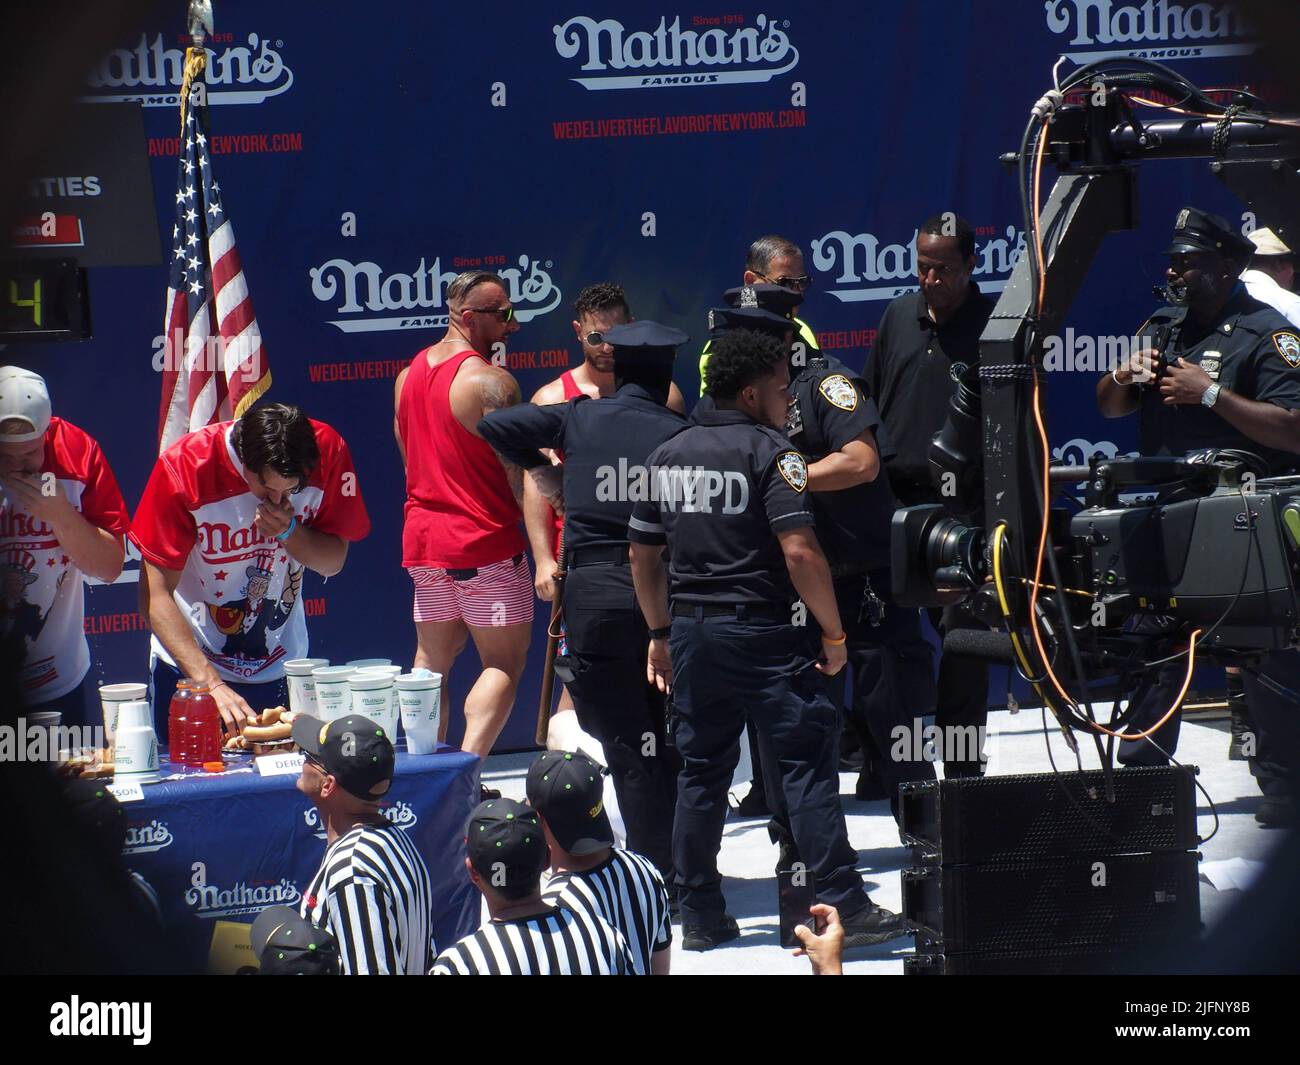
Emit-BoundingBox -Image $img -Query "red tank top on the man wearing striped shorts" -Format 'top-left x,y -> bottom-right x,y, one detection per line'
398,350 -> 528,570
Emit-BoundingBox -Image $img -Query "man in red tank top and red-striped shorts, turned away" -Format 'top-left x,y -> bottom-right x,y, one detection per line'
394,270 -> 533,758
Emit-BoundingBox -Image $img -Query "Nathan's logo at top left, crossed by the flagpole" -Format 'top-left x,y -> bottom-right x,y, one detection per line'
82,34 -> 294,107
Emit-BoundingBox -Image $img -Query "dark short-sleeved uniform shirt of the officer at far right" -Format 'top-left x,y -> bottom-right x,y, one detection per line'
1139,286 -> 1300,473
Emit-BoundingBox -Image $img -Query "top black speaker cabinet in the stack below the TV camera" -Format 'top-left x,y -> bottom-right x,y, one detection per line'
901,766 -> 1197,866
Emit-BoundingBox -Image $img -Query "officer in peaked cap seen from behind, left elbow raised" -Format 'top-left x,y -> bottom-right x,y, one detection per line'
478,321 -> 688,879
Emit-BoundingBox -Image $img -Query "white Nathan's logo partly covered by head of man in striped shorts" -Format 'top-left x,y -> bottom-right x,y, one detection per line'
309,255 -> 562,333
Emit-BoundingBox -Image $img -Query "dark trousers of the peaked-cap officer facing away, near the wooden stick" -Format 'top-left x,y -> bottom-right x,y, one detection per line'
556,564 -> 681,883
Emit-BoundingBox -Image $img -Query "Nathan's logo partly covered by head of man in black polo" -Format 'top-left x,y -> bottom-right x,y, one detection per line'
811,225 -> 1024,303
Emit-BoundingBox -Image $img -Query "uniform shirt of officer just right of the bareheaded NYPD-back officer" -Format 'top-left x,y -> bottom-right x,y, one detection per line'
785,355 -> 894,570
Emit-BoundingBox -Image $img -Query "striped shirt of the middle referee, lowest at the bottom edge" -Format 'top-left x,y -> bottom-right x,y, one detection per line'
429,908 -> 633,977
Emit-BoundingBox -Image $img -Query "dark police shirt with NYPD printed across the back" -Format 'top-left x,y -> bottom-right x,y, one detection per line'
628,410 -> 814,605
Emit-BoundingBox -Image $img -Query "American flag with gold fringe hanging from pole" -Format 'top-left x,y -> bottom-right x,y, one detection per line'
159,98 -> 270,454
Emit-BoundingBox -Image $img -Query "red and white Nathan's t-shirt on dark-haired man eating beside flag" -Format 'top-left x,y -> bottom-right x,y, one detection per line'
130,420 -> 371,683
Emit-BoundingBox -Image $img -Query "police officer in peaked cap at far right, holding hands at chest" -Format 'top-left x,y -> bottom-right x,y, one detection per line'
1097,208 -> 1300,823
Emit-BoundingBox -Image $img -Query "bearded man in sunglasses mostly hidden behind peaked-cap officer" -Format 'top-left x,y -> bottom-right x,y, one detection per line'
524,281 -> 686,750
